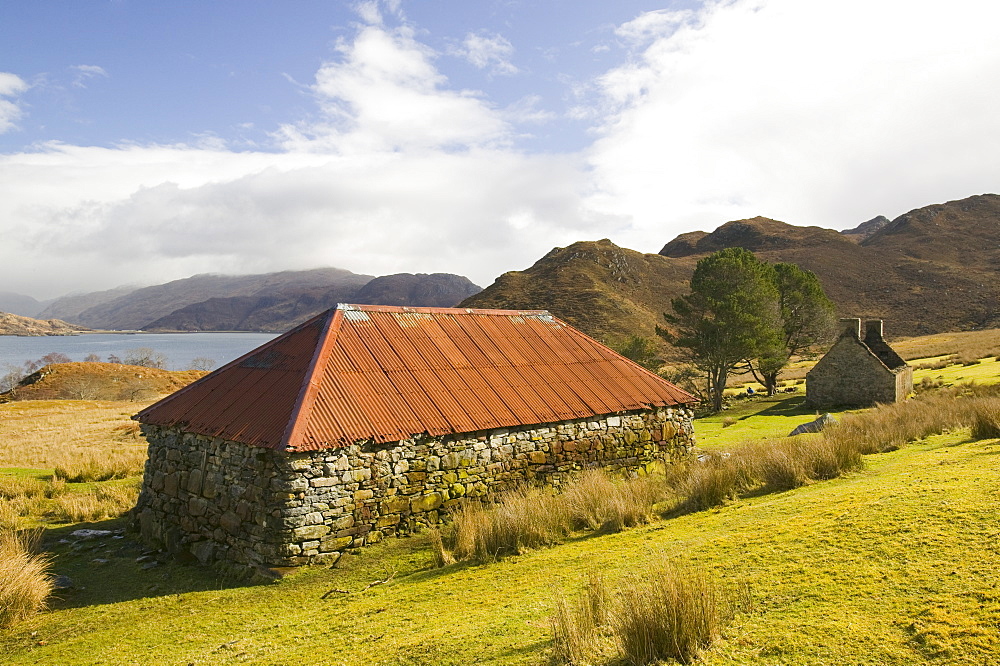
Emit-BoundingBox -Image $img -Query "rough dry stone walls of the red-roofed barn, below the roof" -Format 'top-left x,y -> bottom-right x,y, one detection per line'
134,408 -> 694,566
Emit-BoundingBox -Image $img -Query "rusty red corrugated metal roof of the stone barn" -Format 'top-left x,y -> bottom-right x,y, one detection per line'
136,305 -> 695,451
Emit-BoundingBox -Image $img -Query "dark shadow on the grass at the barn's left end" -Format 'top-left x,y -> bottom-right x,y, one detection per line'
42,518 -> 262,609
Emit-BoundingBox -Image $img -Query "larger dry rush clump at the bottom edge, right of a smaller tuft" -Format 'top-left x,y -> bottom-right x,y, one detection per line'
612,560 -> 725,665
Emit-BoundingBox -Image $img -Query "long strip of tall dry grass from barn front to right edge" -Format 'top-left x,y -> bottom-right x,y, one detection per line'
446,385 -> 1000,566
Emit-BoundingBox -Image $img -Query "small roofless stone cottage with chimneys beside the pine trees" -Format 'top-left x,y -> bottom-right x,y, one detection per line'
806,319 -> 913,407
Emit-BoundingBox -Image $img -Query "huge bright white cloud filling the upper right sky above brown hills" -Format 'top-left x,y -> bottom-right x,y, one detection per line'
589,0 -> 1000,251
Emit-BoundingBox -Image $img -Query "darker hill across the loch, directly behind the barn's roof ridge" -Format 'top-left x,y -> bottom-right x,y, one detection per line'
143,273 -> 479,331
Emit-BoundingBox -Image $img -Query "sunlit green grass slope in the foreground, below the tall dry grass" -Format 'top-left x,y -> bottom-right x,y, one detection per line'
7,426 -> 1000,666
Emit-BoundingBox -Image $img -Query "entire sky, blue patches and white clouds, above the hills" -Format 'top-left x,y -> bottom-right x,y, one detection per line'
0,0 -> 1000,298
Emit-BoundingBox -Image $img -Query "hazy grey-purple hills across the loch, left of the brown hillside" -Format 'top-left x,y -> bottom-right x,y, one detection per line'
30,268 -> 480,331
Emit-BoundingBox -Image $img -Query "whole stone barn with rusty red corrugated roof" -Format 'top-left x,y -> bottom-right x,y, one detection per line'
133,305 -> 695,566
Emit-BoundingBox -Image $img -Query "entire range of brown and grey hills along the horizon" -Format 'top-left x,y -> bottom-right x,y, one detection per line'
0,194 -> 1000,343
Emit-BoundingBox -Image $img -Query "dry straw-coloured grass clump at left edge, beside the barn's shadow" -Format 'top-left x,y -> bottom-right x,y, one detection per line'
0,530 -> 53,629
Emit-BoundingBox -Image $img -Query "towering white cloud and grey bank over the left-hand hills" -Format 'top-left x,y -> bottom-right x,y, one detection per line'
0,25 -> 596,297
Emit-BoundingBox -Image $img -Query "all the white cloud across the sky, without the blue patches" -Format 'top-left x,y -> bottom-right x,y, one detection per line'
0,0 -> 1000,297
